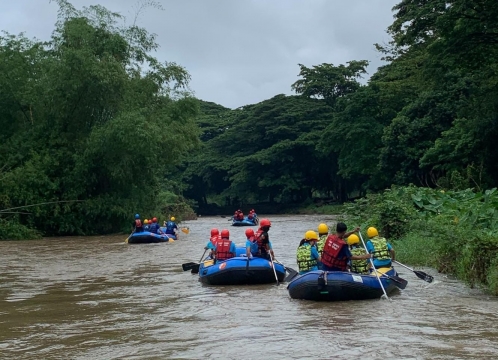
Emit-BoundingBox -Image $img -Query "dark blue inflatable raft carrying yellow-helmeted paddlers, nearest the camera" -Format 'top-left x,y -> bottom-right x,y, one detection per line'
287,268 -> 397,301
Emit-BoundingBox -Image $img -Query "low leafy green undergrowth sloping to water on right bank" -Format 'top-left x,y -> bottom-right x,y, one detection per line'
344,187 -> 498,295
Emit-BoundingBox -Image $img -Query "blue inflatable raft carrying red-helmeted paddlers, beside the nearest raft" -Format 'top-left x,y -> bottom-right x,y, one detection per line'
199,256 -> 285,285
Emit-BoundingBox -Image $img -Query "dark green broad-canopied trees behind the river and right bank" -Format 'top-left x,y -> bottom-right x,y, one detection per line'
182,0 -> 498,214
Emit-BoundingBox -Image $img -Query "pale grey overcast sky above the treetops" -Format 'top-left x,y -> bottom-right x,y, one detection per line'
0,0 -> 399,108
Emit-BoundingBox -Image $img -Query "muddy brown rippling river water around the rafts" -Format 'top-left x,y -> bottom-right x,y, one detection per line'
0,216 -> 498,360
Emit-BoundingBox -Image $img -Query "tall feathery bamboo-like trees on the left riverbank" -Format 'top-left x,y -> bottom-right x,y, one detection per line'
0,0 -> 198,239
